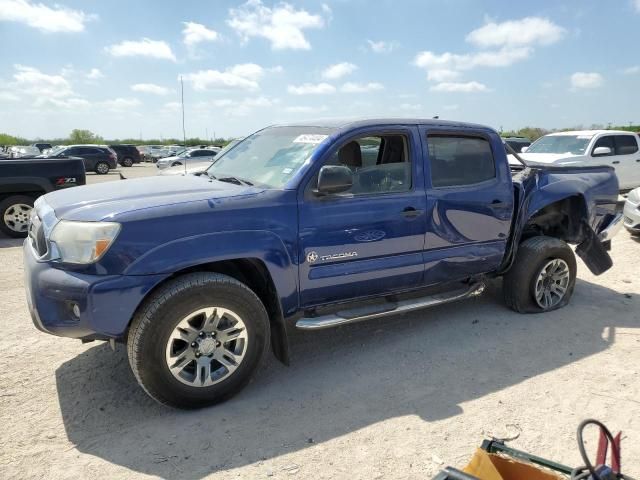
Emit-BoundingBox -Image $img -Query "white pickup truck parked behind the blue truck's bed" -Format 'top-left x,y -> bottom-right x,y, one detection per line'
520,130 -> 640,190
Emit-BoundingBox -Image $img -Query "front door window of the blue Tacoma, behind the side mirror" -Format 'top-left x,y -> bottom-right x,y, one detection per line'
320,135 -> 411,195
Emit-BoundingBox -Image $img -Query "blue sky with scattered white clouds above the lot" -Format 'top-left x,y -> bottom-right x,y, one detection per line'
0,0 -> 640,139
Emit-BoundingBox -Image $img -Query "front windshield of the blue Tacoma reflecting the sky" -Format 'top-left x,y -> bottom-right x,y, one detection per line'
207,127 -> 333,188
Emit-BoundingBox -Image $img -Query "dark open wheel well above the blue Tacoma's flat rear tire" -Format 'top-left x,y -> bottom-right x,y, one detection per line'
521,196 -> 587,243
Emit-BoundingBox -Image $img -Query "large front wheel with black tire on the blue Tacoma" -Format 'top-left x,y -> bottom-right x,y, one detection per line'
127,272 -> 270,409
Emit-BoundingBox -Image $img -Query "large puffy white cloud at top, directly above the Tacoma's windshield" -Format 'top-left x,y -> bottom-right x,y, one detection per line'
227,0 -> 330,50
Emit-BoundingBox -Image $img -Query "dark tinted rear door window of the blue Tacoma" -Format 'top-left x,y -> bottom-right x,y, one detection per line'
427,135 -> 496,187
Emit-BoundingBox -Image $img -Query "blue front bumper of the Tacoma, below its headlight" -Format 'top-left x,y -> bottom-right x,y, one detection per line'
23,239 -> 167,339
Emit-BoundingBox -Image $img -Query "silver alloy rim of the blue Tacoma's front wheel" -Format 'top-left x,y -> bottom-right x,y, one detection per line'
165,306 -> 249,388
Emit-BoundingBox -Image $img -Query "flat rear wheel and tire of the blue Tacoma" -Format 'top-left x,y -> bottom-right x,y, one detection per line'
503,236 -> 576,313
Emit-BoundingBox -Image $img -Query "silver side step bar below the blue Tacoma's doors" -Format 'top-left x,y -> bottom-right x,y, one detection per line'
296,283 -> 485,330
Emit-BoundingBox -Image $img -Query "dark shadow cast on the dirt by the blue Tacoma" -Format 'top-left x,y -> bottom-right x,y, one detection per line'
56,280 -> 640,478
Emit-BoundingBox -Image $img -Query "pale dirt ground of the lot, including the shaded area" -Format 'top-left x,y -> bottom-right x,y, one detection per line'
0,166 -> 640,479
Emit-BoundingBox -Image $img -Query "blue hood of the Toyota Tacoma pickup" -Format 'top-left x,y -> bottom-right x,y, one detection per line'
44,175 -> 263,221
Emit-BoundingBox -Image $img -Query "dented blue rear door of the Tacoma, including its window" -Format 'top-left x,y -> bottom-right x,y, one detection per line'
421,128 -> 514,284
